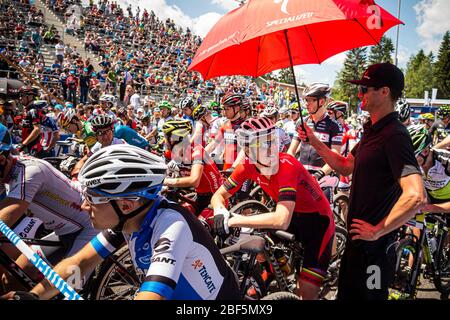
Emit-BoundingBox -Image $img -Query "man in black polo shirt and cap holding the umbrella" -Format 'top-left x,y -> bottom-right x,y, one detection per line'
299,63 -> 425,300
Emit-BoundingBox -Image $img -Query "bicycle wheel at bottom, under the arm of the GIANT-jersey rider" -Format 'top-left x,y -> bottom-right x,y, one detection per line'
91,245 -> 141,300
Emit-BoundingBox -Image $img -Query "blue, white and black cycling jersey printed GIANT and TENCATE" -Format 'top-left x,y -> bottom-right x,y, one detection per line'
91,197 -> 239,300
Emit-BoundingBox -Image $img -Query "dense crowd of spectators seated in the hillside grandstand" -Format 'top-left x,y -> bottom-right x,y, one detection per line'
0,0 -> 302,117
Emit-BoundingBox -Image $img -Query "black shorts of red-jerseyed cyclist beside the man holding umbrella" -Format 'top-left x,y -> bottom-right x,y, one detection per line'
287,212 -> 334,285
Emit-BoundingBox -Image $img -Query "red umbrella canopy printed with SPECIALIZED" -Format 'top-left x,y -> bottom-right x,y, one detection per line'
189,0 -> 402,80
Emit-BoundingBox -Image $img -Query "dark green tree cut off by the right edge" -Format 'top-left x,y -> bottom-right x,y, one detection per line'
433,31 -> 450,99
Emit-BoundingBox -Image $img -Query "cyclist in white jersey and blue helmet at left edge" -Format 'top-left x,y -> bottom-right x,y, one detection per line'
0,124 -> 98,294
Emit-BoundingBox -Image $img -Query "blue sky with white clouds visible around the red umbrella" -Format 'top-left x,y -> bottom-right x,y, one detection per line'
123,0 -> 450,84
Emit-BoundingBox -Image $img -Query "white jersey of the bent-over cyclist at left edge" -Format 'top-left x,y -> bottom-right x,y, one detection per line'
0,156 -> 93,235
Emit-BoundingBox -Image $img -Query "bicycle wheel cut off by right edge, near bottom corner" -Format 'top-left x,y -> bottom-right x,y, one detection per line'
433,232 -> 450,294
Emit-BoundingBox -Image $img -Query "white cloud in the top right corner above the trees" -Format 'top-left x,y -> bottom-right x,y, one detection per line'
414,0 -> 450,54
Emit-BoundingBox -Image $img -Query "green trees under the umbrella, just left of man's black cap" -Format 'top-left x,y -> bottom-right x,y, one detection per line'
332,48 -> 367,112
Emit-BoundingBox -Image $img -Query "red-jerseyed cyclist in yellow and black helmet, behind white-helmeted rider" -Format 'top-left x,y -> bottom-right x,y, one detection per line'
162,119 -> 223,215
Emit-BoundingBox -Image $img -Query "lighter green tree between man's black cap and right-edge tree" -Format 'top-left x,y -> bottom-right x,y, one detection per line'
405,50 -> 434,98
